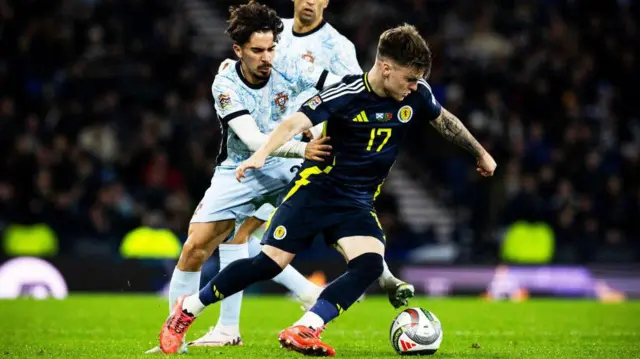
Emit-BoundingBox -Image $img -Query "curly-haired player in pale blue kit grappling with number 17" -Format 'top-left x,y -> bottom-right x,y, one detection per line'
148,1 -> 341,353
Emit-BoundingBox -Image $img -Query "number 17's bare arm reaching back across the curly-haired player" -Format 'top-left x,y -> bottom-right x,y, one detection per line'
236,112 -> 320,181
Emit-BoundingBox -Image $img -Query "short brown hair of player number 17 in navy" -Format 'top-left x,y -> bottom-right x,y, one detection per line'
378,24 -> 431,77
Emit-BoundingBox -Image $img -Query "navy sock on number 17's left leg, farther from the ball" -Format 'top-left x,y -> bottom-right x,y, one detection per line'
198,253 -> 282,306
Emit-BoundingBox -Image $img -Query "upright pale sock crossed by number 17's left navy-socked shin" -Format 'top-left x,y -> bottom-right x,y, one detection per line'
218,243 -> 249,331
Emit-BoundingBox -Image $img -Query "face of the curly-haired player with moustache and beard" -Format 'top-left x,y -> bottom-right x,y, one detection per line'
233,31 -> 276,80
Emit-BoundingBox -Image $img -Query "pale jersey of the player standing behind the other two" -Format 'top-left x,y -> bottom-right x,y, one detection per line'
276,19 -> 363,112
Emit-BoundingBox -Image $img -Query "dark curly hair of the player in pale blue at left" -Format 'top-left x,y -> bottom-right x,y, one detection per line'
225,0 -> 284,46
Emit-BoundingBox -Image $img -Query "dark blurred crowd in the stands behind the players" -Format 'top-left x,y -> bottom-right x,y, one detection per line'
0,0 -> 640,262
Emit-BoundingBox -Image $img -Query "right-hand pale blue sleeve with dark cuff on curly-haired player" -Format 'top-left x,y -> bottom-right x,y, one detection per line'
274,55 -> 329,97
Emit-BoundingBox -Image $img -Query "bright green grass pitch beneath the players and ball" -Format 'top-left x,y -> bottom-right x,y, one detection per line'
0,295 -> 640,359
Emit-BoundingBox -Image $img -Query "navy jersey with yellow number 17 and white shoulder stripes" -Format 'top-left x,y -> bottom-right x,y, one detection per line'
299,73 -> 442,206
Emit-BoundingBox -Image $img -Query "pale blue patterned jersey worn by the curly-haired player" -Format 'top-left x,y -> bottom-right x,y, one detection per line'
211,56 -> 328,167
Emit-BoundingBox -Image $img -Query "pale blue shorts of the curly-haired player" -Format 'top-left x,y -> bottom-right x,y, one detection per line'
191,158 -> 302,223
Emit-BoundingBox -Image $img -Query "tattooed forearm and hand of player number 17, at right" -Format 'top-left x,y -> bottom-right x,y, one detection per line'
431,108 -> 497,177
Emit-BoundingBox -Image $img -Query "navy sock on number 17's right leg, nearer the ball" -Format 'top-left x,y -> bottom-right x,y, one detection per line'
311,253 -> 383,323
